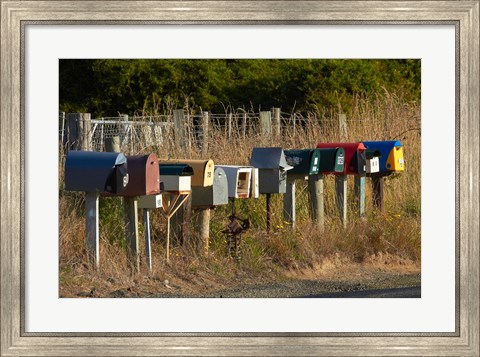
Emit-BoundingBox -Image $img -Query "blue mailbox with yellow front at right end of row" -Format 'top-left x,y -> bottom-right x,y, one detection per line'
363,140 -> 405,174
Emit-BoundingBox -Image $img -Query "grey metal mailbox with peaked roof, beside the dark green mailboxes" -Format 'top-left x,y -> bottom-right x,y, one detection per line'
250,148 -> 293,193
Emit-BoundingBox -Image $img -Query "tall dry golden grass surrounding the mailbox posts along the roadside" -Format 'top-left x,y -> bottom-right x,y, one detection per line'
59,93 -> 421,297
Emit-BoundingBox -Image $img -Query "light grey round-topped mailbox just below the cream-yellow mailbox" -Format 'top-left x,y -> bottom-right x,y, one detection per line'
192,167 -> 228,207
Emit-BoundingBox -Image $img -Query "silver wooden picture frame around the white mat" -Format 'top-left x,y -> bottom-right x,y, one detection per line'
0,0 -> 480,357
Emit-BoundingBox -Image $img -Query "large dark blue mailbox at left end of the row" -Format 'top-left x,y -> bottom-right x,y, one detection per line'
65,151 -> 128,194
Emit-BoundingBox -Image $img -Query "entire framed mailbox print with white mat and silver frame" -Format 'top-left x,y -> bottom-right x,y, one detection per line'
0,0 -> 480,357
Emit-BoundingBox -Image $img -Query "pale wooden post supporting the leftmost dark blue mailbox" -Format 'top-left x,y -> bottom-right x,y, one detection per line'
85,192 -> 100,269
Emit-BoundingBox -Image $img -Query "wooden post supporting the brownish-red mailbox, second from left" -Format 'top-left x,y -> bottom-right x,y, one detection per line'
123,197 -> 140,271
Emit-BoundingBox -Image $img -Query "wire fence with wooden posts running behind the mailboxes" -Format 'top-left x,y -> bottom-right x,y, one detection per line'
59,104 -> 420,164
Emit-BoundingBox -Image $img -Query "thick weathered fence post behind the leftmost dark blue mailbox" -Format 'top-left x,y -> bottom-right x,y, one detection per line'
67,113 -> 92,151
